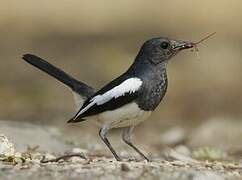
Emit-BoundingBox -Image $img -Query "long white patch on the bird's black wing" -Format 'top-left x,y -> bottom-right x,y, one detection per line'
76,78 -> 142,117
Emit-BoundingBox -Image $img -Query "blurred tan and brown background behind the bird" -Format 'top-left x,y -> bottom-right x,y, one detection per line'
0,0 -> 242,158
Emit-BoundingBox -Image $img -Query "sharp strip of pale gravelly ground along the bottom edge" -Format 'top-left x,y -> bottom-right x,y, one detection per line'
0,157 -> 242,180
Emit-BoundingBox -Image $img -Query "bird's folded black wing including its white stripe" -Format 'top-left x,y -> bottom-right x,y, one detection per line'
68,77 -> 142,122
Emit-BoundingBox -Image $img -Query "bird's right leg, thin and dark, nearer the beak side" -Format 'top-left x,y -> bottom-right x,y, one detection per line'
122,126 -> 150,161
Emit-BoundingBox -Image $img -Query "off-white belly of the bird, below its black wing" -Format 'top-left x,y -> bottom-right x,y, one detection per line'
96,103 -> 151,128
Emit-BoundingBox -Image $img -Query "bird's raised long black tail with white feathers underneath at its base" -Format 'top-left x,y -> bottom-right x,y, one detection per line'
23,54 -> 95,110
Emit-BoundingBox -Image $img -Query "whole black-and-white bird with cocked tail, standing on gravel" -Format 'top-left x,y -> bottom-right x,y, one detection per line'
22,37 -> 195,161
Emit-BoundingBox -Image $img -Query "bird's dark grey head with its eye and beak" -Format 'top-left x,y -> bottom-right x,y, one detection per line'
138,37 -> 195,64
